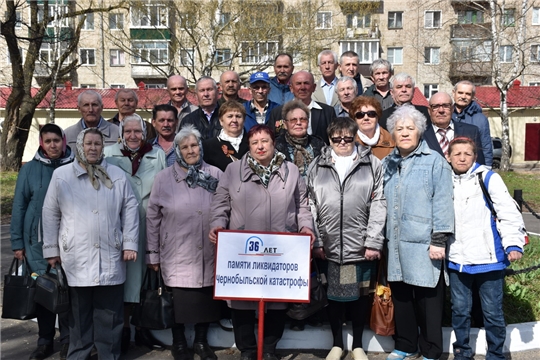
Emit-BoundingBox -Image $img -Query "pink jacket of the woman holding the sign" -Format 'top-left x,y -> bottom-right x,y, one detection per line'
210,155 -> 313,309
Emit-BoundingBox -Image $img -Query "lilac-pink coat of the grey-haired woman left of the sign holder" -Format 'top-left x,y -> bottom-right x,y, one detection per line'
146,162 -> 222,288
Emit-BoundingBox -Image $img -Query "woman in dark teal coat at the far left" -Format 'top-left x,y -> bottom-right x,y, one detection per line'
11,124 -> 75,360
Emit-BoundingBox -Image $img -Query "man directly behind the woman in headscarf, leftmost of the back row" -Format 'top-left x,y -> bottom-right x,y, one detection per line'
65,90 -> 120,149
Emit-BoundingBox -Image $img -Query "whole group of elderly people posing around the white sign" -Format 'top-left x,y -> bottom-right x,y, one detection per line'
11,50 -> 524,360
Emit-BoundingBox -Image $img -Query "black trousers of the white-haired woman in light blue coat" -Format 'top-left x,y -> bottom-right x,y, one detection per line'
390,271 -> 445,359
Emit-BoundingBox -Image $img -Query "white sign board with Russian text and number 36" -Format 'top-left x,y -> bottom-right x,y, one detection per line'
214,231 -> 310,302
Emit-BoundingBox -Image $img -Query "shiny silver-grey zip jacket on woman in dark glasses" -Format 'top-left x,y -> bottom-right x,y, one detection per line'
308,145 -> 386,264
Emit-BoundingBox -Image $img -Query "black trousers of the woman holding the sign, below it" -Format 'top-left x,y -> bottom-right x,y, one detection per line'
231,309 -> 287,353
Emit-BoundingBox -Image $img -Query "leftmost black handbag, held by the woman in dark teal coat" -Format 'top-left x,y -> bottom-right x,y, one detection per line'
2,258 -> 36,320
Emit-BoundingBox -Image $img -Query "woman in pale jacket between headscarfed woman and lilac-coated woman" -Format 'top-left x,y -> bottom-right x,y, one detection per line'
105,114 -> 167,353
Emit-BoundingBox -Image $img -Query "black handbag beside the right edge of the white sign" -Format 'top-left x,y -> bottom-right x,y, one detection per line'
287,259 -> 328,320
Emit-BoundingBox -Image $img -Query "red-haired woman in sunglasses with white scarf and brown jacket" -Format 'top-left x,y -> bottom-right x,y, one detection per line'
350,96 -> 396,160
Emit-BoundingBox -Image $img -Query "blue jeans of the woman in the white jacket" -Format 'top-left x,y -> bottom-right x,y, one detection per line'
448,269 -> 506,360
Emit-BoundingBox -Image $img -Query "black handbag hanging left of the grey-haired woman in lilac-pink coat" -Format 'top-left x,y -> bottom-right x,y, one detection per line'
131,268 -> 175,330
